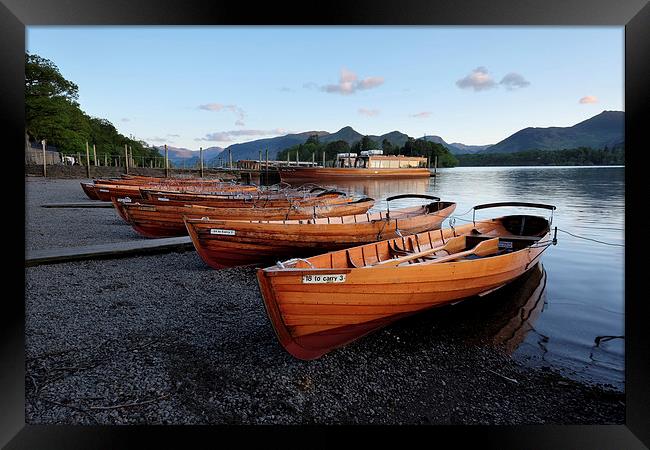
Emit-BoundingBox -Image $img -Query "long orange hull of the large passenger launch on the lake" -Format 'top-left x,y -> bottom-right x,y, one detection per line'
278,167 -> 431,183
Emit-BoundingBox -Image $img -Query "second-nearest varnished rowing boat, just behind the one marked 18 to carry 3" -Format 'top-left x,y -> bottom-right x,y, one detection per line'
185,194 -> 456,269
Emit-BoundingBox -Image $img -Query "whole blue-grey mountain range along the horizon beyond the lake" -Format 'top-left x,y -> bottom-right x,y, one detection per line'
153,111 -> 625,165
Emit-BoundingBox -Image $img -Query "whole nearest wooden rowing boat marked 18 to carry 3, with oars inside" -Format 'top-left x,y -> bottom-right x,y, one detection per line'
257,202 -> 556,359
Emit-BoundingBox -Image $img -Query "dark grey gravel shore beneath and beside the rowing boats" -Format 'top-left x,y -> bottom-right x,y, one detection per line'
25,180 -> 625,424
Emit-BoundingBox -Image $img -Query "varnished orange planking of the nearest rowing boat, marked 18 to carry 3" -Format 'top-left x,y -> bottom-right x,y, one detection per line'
258,211 -> 550,359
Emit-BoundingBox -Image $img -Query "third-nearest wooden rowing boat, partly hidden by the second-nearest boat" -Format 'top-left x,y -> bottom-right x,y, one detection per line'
120,198 -> 375,237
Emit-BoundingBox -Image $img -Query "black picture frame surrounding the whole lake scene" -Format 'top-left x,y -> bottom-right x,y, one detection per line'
0,0 -> 650,449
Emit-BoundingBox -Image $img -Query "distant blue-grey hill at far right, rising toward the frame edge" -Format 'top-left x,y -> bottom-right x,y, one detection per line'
484,111 -> 625,153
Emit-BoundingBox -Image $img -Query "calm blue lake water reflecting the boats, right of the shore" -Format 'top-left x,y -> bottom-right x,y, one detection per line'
296,167 -> 625,390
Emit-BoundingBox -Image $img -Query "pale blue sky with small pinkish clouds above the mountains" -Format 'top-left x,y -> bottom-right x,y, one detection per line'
26,26 -> 624,150
